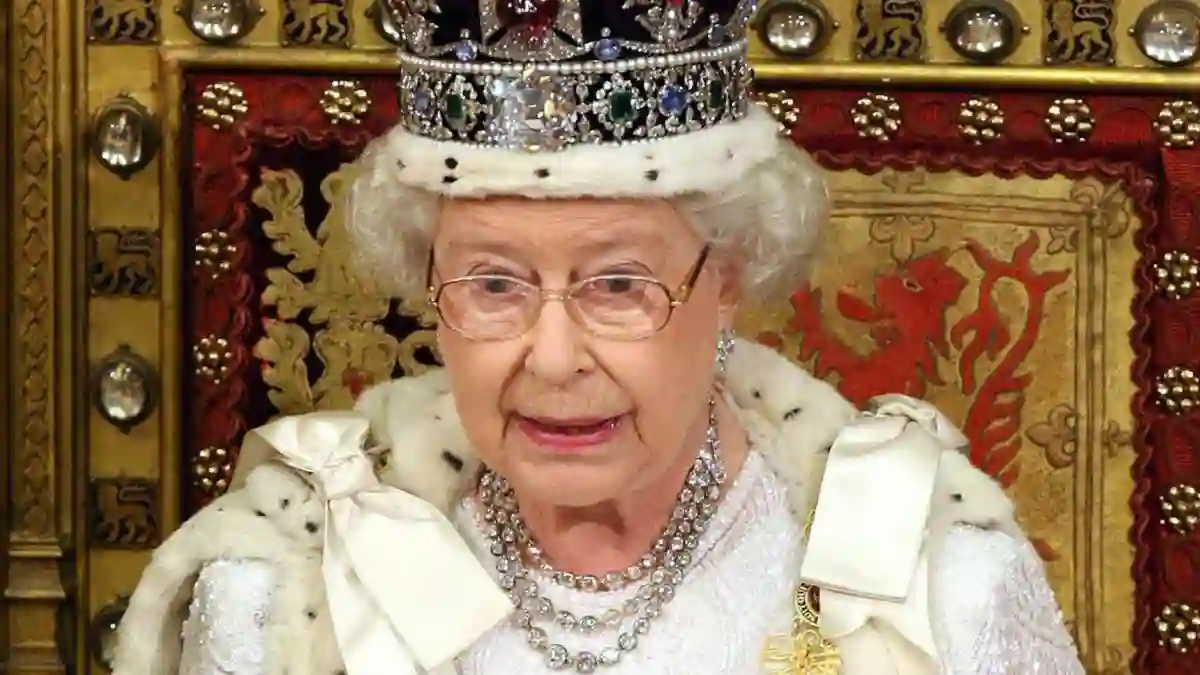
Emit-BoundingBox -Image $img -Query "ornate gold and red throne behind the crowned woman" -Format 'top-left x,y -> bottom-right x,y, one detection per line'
0,0 -> 1200,675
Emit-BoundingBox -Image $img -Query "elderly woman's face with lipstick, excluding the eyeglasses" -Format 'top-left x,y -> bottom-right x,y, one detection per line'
434,198 -> 737,507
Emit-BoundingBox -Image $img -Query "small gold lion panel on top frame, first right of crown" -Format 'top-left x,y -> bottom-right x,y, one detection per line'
854,0 -> 925,61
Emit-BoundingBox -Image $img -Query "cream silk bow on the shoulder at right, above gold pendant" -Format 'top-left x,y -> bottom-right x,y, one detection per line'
800,395 -> 967,658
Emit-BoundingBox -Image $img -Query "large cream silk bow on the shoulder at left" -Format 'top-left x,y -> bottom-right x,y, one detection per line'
246,412 -> 512,675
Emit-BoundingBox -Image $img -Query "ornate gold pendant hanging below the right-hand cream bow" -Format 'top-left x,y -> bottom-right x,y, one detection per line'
763,584 -> 841,675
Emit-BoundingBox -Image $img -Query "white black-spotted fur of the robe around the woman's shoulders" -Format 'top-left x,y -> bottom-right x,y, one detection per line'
114,341 -> 1020,675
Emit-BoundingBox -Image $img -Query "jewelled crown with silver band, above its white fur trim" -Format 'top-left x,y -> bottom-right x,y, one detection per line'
386,0 -> 755,151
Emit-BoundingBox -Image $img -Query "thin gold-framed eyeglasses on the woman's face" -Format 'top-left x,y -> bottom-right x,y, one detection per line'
425,245 -> 709,340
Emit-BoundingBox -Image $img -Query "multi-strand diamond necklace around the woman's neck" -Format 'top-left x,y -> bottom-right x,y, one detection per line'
479,402 -> 726,673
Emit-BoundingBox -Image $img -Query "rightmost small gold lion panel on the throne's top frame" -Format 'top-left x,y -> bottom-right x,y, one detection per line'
1043,0 -> 1116,65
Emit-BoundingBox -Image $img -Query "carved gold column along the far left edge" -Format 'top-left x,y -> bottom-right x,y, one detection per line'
2,0 -> 84,674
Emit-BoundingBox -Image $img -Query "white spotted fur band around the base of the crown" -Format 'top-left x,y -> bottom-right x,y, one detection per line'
379,106 -> 791,198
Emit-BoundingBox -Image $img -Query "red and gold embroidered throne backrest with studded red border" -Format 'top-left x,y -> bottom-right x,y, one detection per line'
182,73 -> 1200,675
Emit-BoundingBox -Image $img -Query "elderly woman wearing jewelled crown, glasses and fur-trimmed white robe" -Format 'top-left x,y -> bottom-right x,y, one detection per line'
115,0 -> 1082,675
